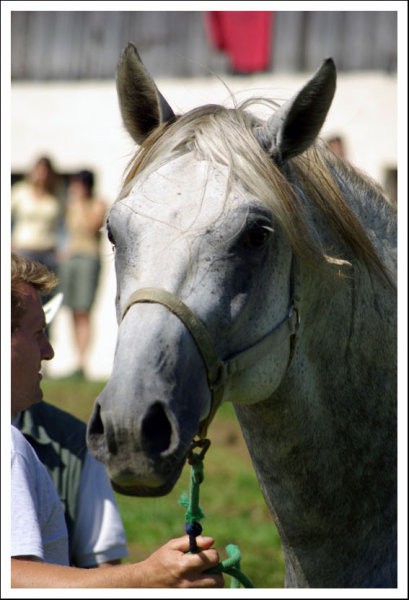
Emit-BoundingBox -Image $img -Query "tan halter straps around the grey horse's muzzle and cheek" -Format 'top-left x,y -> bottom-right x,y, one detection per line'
121,259 -> 300,438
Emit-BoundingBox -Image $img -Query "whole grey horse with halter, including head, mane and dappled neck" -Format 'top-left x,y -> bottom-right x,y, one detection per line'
88,44 -> 397,588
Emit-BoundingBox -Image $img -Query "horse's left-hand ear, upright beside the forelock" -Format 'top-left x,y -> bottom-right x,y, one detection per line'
116,42 -> 175,144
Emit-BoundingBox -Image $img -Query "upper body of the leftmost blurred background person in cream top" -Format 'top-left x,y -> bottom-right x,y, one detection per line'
11,156 -> 63,290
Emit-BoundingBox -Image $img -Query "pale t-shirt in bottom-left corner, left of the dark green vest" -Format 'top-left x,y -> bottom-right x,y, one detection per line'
11,425 -> 69,566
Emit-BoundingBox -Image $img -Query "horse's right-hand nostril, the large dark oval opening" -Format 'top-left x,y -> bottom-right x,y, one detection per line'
141,402 -> 172,457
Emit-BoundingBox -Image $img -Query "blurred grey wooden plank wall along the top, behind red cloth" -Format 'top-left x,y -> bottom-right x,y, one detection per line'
11,10 -> 397,81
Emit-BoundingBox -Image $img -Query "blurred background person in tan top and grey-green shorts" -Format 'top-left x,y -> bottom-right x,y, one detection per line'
58,170 -> 107,378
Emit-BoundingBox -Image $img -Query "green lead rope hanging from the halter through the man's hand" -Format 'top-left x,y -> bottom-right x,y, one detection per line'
179,439 -> 254,588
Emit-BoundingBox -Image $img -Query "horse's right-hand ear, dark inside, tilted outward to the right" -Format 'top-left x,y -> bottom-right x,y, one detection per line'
254,58 -> 336,164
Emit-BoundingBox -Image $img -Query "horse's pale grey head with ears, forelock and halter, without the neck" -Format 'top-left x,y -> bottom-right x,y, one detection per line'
88,44 -> 336,496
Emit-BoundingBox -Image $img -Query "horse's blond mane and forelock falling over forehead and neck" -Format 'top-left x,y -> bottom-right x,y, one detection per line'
120,99 -> 396,287
